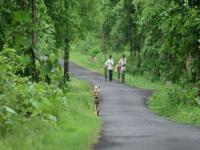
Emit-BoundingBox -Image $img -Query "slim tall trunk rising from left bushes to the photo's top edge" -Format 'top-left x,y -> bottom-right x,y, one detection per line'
31,0 -> 36,81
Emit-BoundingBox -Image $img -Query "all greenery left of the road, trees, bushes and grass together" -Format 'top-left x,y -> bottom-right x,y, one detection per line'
0,0 -> 101,150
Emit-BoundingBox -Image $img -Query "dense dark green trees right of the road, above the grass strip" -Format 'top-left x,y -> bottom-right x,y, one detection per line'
99,0 -> 200,82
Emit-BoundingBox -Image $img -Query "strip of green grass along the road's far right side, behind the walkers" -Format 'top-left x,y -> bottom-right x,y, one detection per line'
71,51 -> 200,126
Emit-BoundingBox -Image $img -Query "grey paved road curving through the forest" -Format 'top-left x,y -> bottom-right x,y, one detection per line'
70,63 -> 200,150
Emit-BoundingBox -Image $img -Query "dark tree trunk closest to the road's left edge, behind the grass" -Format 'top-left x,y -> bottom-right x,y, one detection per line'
64,38 -> 69,83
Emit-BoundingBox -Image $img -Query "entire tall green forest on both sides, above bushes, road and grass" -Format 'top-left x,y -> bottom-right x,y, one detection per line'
0,0 -> 200,82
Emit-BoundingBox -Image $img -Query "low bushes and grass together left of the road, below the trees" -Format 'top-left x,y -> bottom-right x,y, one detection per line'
0,49 -> 101,150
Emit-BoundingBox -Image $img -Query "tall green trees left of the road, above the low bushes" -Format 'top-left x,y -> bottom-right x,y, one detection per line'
0,0 -> 100,82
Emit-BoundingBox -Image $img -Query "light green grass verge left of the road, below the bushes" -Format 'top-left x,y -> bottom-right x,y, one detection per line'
0,78 -> 101,150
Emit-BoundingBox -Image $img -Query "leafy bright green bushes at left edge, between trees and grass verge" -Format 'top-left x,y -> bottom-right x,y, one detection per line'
0,51 -> 65,134
